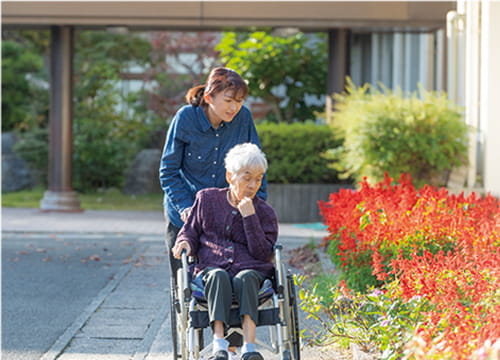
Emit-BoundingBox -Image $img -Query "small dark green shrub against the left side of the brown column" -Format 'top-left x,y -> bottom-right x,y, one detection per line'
12,128 -> 49,184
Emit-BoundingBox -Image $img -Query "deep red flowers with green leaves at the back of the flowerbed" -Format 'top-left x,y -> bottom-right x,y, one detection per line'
319,175 -> 499,291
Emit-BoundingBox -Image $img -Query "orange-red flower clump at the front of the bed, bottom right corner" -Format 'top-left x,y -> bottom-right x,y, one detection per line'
391,243 -> 500,360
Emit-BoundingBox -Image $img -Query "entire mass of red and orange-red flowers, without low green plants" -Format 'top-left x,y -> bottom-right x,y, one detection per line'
320,176 -> 500,360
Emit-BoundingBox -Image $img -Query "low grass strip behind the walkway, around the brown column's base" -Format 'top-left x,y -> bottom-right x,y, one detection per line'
2,188 -> 163,211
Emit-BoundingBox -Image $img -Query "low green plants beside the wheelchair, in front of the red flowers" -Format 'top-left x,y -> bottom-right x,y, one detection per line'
298,278 -> 431,360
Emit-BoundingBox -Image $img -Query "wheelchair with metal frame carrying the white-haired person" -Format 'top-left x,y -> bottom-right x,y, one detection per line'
171,244 -> 300,360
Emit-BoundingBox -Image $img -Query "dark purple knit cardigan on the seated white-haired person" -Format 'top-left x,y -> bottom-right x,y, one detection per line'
176,188 -> 278,277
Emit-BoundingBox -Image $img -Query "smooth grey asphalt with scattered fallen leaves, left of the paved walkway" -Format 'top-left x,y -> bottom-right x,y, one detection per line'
2,232 -> 148,360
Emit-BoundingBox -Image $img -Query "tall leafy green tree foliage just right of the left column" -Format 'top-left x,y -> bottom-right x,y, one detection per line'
73,31 -> 155,191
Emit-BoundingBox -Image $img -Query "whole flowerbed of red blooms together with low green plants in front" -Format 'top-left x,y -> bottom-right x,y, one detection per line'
300,175 -> 500,360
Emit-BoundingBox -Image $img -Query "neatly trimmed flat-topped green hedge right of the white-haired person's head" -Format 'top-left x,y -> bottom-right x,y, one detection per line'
257,123 -> 339,184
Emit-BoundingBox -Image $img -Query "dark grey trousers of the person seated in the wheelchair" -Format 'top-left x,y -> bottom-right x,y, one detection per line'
201,268 -> 266,327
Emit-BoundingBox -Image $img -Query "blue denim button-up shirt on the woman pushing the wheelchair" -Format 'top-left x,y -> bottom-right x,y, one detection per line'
160,105 -> 267,228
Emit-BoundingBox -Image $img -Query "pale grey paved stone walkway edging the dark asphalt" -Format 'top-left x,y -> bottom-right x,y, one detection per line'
1,208 -> 340,360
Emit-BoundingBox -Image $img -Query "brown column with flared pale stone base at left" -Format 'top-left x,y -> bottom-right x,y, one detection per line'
40,26 -> 82,212
